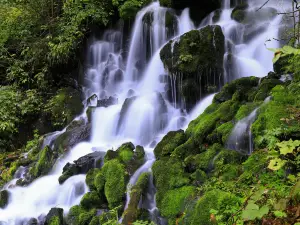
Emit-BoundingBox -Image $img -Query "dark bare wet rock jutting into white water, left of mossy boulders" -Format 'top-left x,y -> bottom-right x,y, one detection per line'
58,152 -> 104,184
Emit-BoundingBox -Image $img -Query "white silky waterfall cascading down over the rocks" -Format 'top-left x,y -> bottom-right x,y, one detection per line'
0,0 -> 290,224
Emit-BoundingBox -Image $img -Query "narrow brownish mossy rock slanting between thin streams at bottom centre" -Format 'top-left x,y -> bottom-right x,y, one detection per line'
122,173 -> 150,225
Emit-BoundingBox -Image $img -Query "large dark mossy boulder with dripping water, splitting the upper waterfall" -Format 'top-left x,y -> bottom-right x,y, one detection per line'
160,26 -> 225,109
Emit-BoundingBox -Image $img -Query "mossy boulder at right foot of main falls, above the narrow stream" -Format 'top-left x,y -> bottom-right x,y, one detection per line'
154,130 -> 186,159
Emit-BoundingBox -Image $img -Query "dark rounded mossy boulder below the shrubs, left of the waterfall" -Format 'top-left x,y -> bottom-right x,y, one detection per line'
46,87 -> 83,129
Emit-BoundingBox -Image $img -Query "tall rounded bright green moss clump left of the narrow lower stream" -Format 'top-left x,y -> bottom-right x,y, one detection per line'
102,159 -> 126,208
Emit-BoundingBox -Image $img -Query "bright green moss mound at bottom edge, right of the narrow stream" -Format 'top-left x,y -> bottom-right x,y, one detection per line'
160,186 -> 196,219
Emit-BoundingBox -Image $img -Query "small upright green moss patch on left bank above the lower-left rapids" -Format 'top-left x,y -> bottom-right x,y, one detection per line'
32,146 -> 55,177
